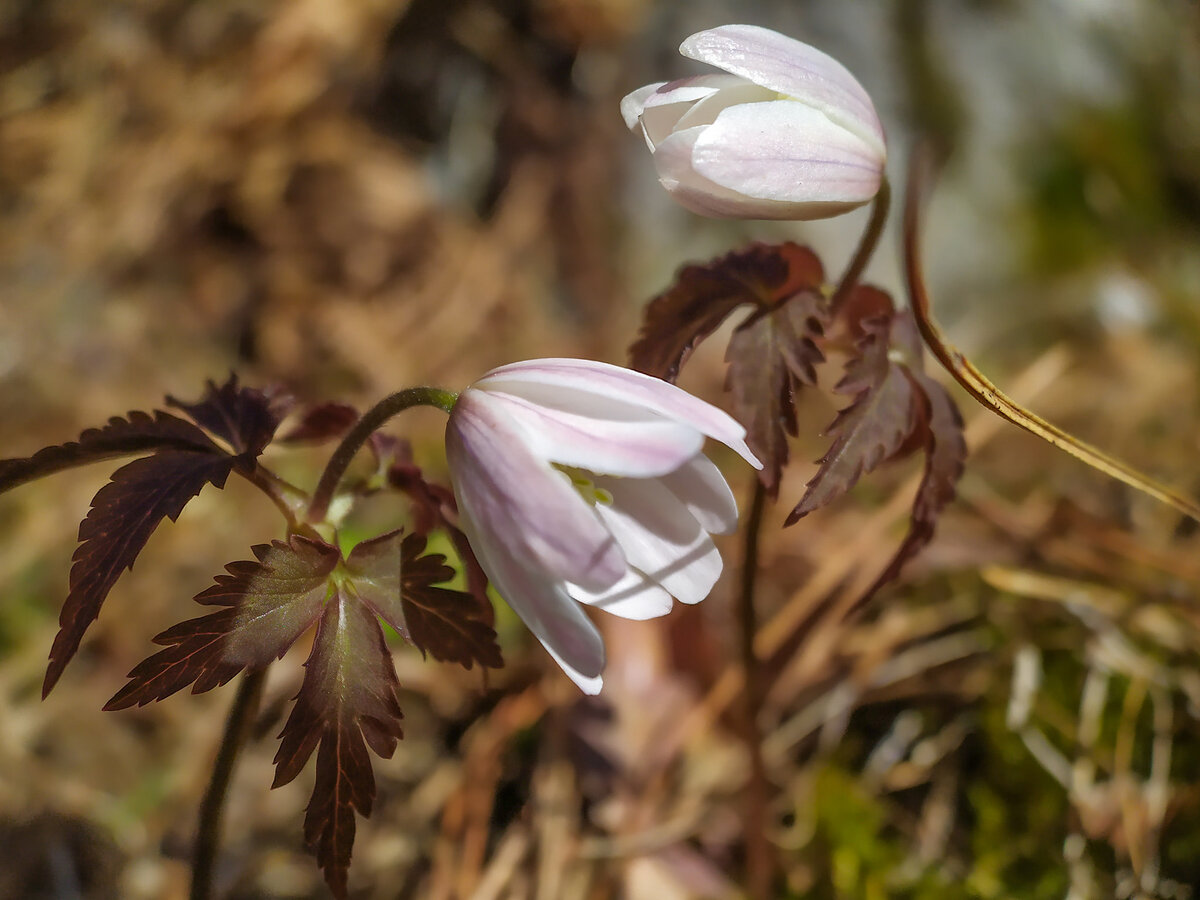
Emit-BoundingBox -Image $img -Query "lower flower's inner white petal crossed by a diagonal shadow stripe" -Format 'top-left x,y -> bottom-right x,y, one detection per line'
596,478 -> 722,604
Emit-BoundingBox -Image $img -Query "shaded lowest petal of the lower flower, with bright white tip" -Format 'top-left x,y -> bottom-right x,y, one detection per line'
460,515 -> 605,694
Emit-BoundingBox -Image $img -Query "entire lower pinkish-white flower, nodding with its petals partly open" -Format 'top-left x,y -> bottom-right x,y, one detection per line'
446,359 -> 761,694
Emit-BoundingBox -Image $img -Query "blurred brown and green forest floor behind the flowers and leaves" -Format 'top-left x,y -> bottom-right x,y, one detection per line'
0,0 -> 1200,900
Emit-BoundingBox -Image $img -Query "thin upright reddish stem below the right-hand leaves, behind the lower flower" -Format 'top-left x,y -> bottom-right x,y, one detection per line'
737,478 -> 775,898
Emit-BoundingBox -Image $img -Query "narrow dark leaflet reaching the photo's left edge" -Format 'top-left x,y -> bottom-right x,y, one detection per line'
0,410 -> 220,493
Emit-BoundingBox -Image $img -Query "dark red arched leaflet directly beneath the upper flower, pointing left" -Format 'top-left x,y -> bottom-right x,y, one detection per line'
629,242 -> 824,382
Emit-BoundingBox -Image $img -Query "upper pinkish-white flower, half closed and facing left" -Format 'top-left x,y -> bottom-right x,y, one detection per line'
620,25 -> 887,220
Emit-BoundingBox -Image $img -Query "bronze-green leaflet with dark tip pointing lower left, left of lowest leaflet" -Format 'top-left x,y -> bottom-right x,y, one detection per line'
104,535 -> 340,709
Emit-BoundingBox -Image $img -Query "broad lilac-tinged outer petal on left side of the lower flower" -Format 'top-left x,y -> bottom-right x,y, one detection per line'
446,390 -> 626,590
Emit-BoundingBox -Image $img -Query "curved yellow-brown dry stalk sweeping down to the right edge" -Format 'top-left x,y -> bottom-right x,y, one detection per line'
904,154 -> 1200,521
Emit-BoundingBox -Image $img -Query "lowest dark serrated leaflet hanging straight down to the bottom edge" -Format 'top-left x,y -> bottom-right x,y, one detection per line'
272,592 -> 402,900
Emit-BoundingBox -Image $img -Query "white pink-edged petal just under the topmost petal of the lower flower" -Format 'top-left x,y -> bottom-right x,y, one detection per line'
477,390 -> 704,478
